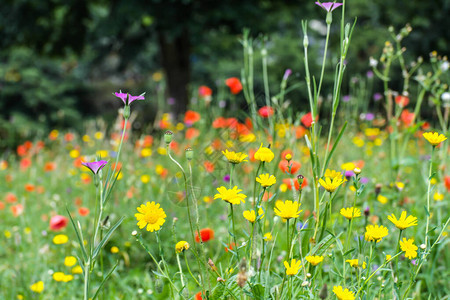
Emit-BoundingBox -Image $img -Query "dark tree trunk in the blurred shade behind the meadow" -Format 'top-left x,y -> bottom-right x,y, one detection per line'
158,29 -> 191,117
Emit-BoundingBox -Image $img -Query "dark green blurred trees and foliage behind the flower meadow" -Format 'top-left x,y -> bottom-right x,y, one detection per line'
0,0 -> 450,146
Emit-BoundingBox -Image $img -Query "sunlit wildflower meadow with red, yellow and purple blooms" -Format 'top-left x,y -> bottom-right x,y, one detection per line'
0,0 -> 450,300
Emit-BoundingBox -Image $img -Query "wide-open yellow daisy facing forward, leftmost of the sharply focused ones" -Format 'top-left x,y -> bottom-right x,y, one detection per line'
134,201 -> 166,232
